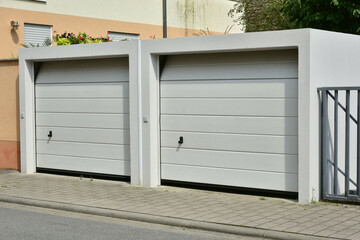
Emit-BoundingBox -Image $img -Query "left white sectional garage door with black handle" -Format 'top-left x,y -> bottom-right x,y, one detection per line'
35,58 -> 130,176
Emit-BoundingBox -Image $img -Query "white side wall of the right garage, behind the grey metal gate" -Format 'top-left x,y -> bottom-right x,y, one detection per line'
309,30 -> 360,199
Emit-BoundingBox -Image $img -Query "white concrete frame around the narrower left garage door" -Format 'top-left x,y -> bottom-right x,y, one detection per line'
19,40 -> 141,185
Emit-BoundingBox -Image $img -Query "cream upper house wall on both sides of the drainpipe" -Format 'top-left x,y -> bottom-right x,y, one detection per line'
0,0 -> 240,33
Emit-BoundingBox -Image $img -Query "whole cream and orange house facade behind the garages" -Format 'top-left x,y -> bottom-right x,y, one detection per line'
0,0 -> 241,169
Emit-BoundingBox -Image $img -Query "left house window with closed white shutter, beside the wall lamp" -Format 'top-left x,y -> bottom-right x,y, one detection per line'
24,23 -> 52,47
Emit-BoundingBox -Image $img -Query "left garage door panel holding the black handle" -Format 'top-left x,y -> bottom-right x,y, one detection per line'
36,127 -> 130,144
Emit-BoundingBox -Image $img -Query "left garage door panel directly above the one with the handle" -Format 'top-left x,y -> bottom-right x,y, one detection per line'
36,113 -> 130,129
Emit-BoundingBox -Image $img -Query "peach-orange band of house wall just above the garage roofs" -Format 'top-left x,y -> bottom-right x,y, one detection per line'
0,7 -> 194,59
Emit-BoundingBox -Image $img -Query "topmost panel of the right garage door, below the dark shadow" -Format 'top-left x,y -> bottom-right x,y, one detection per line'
161,62 -> 298,80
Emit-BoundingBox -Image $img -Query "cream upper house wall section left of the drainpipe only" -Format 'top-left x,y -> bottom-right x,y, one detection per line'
0,0 -> 162,25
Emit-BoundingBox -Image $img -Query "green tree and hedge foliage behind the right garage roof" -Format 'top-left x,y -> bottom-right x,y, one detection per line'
229,0 -> 360,34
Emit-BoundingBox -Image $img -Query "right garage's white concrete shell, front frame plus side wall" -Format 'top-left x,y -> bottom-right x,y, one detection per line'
141,29 -> 360,203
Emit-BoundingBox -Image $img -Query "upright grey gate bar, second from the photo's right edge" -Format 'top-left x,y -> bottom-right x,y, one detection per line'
345,90 -> 350,197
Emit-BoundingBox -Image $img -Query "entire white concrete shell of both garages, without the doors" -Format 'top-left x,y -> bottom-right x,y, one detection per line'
19,29 -> 360,204
